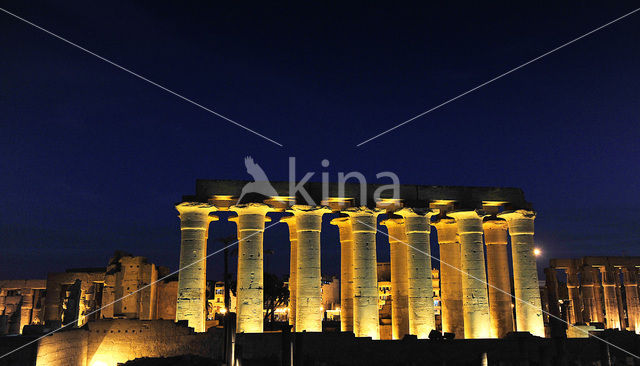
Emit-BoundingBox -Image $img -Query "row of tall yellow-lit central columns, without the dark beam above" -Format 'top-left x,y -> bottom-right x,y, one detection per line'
176,203 -> 544,339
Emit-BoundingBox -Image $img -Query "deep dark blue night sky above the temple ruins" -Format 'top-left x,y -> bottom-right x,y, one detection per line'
0,0 -> 640,279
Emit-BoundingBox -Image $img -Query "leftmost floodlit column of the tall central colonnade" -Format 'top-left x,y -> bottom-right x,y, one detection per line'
176,202 -> 218,332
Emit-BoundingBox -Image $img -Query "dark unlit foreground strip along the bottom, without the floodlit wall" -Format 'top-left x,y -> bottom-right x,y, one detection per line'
0,331 -> 640,366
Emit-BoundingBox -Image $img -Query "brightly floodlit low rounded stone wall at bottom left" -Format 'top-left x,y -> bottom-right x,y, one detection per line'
36,319 -> 222,366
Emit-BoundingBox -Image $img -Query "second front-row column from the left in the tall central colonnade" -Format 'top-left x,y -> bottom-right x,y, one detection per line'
229,203 -> 271,333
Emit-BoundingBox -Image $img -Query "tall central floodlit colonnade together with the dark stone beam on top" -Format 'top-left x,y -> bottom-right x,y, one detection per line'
176,180 -> 545,339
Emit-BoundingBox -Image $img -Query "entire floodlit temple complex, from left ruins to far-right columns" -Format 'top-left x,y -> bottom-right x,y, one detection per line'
0,180 -> 640,366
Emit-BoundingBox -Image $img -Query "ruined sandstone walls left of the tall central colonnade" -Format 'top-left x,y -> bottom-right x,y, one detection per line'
0,252 -> 178,335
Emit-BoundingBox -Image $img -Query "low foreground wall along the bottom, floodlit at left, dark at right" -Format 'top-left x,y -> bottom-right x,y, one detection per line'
6,320 -> 640,366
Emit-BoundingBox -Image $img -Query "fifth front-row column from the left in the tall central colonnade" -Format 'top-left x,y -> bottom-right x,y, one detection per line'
392,208 -> 436,339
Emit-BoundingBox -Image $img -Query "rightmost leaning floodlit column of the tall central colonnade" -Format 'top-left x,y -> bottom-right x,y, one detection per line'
498,210 -> 544,337
